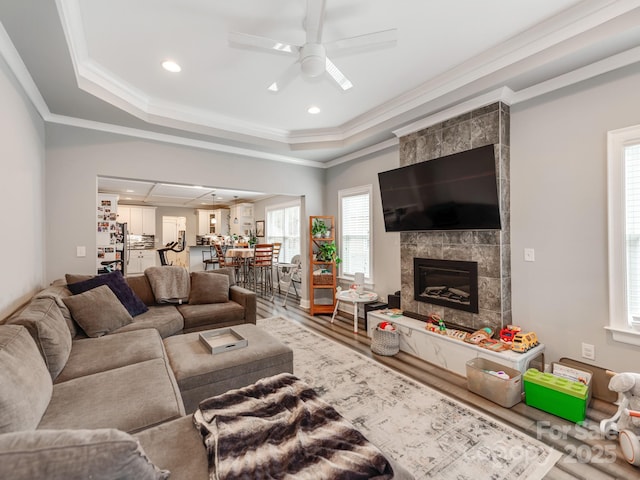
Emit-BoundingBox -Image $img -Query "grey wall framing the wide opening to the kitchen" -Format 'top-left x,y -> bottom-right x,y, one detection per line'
46,124 -> 324,281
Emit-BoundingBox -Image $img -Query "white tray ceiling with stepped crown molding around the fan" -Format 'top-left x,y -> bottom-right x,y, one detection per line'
0,0 -> 640,172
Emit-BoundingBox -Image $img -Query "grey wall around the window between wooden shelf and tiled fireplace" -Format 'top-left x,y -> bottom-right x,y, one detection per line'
324,146 -> 400,301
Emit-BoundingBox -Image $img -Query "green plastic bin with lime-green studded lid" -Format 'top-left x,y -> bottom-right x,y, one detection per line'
523,368 -> 589,423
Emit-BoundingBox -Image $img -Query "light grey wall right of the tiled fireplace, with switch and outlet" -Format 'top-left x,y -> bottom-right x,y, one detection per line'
511,65 -> 640,371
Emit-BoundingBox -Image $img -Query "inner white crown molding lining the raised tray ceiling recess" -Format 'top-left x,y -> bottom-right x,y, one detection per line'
56,0 -> 640,147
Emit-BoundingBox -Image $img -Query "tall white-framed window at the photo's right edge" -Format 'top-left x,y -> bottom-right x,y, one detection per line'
608,125 -> 640,345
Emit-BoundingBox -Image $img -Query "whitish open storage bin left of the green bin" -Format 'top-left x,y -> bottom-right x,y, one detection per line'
467,357 -> 522,408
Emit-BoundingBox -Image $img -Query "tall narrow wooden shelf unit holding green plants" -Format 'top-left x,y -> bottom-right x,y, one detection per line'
309,215 -> 337,315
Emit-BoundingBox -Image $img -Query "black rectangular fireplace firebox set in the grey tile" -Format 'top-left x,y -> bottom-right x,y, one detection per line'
413,258 -> 478,313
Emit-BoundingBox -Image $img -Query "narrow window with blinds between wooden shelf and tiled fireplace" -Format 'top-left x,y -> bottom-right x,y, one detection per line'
338,185 -> 373,281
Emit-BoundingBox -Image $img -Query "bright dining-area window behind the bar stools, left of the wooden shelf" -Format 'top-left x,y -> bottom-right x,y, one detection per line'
265,203 -> 300,263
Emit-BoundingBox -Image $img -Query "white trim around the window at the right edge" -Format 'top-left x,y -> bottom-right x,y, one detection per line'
605,125 -> 640,346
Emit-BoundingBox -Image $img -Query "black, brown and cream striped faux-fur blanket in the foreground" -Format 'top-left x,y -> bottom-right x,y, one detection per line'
194,373 -> 393,480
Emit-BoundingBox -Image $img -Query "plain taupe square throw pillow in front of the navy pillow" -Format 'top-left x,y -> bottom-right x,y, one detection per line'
62,285 -> 133,337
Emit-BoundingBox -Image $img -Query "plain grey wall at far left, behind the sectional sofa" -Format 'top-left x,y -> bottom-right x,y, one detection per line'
0,57 -> 46,318
